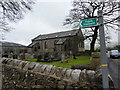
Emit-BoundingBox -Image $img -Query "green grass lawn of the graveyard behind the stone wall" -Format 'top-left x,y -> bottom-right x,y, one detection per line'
26,56 -> 90,68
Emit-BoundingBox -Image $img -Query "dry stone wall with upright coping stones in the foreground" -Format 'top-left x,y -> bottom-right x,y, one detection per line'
1,58 -> 113,90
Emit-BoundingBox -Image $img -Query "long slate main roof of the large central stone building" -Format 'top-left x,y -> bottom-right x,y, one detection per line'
32,30 -> 77,41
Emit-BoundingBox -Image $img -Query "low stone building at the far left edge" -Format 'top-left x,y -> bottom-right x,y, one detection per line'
0,41 -> 27,58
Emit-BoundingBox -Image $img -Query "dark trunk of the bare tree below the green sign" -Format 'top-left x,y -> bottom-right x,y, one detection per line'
90,26 -> 99,53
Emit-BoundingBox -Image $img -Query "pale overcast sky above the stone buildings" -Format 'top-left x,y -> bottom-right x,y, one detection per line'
1,0 -> 117,45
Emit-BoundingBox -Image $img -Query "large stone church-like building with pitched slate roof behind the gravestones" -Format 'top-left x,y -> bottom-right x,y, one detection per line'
29,29 -> 84,58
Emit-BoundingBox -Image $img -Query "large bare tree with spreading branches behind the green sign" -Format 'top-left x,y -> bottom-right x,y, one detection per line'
64,0 -> 120,52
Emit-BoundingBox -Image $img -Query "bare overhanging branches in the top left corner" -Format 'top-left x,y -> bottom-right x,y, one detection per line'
0,0 -> 34,31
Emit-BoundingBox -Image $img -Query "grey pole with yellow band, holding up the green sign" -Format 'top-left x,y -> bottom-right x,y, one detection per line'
98,10 -> 109,90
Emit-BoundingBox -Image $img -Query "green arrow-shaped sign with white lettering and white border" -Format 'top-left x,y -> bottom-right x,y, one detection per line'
80,18 -> 98,28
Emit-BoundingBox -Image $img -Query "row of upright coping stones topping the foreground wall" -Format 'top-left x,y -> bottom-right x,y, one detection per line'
2,58 -> 95,83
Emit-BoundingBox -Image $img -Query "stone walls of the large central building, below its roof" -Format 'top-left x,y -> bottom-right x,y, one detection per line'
32,32 -> 84,59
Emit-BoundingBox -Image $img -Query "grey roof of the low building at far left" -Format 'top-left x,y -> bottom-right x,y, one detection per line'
0,41 -> 26,47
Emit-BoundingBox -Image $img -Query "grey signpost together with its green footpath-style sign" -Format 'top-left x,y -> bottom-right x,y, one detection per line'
80,10 -> 109,90
